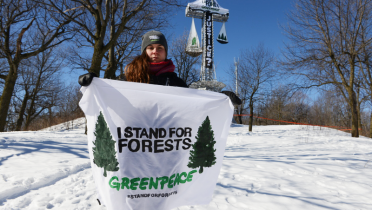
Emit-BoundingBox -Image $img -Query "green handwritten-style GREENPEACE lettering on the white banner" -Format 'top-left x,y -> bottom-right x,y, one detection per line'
109,170 -> 197,191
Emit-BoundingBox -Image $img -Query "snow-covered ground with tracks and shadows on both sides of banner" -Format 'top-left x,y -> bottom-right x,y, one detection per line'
0,119 -> 372,210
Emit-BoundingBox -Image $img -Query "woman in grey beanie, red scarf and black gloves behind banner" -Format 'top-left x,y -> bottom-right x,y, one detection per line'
79,31 -> 242,105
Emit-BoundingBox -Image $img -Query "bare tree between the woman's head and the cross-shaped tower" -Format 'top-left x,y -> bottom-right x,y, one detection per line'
169,31 -> 201,85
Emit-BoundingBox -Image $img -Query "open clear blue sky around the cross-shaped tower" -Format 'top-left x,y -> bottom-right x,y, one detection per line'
169,0 -> 293,86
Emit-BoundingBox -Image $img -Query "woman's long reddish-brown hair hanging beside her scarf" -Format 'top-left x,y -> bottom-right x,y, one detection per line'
125,50 -> 151,83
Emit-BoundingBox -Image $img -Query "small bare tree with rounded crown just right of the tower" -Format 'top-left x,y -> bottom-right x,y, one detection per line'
238,43 -> 275,132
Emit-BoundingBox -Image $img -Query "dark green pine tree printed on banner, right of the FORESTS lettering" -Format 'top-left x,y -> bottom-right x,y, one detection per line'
187,116 -> 216,174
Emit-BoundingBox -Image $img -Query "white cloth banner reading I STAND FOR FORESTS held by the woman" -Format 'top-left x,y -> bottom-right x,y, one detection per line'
79,78 -> 233,210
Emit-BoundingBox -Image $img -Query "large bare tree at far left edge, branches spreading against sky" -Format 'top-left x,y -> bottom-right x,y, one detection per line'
0,0 -> 76,132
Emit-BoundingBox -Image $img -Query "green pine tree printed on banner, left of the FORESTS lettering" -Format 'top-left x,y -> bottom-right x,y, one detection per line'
93,112 -> 119,177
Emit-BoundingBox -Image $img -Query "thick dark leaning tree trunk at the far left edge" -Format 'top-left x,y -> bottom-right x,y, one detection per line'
0,65 -> 18,132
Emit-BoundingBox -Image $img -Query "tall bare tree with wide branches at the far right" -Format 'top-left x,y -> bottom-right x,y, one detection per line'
283,0 -> 372,137
